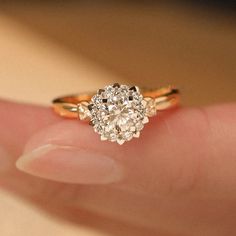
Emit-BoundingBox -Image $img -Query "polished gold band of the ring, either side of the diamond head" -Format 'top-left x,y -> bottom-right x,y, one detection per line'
52,86 -> 179,118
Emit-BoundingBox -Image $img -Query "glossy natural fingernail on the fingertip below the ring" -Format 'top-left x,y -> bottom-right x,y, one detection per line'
16,144 -> 123,184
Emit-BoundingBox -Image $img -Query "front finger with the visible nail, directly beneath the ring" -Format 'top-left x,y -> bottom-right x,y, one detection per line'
17,105 -> 236,195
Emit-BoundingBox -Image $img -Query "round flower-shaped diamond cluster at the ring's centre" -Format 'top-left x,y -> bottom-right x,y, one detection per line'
88,84 -> 148,144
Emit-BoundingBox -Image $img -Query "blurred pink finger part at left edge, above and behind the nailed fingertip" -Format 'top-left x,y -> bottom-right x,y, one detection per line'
0,100 -> 59,161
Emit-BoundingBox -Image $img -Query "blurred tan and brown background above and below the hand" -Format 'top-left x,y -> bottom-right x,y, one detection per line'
0,0 -> 236,236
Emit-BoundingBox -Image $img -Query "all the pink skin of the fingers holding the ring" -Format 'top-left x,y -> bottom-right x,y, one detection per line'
0,98 -> 236,236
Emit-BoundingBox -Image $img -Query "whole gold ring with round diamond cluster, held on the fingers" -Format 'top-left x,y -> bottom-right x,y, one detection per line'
53,83 -> 179,144
